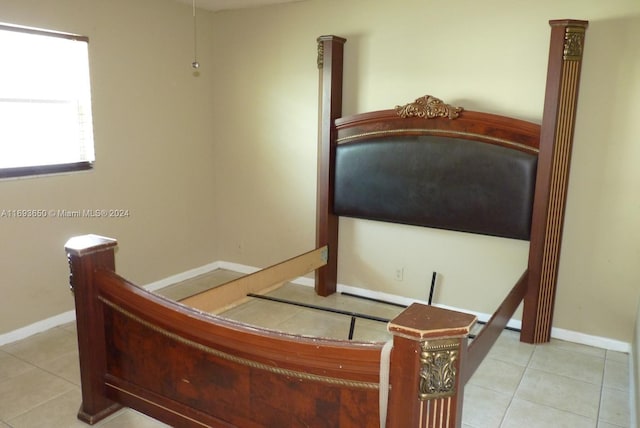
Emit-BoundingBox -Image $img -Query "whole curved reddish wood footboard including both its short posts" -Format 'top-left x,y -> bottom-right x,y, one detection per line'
66,235 -> 475,428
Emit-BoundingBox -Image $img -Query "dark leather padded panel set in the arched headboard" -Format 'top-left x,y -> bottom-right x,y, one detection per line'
333,136 -> 537,240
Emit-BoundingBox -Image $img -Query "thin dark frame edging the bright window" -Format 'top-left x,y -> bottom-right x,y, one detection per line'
0,22 -> 95,179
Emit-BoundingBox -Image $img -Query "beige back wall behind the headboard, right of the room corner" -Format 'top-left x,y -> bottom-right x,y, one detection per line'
214,0 -> 640,341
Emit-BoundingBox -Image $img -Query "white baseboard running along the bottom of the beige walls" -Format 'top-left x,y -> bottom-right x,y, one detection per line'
0,261 -> 631,353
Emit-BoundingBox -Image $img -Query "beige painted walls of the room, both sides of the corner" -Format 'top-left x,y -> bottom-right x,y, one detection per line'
0,0 -> 640,341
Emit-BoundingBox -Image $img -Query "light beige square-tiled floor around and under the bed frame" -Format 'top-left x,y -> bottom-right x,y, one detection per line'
0,272 -> 630,428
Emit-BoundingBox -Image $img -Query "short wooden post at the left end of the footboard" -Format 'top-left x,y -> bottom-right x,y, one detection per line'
65,235 -> 121,424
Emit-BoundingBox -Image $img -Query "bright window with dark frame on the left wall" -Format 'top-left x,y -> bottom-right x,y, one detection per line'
0,24 -> 95,177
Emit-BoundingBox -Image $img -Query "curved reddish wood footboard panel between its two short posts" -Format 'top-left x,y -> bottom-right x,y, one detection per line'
97,271 -> 380,427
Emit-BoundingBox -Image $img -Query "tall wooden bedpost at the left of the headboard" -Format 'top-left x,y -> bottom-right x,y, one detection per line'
316,36 -> 346,296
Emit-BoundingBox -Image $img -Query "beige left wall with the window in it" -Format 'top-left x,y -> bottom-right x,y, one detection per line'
0,0 -> 218,334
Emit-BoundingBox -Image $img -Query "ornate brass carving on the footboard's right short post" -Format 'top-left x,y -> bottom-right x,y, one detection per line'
418,340 -> 459,400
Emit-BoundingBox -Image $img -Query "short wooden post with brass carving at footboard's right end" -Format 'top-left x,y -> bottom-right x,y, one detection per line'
387,303 -> 476,428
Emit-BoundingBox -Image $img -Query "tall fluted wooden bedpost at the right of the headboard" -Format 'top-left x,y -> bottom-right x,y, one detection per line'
521,20 -> 588,343
